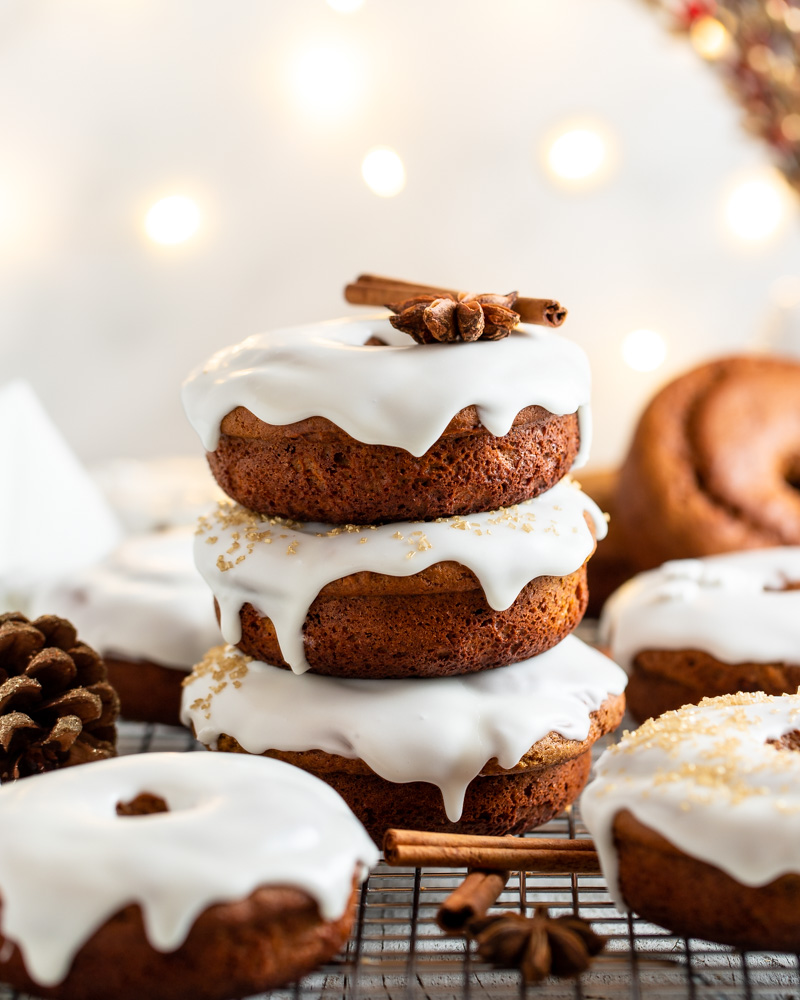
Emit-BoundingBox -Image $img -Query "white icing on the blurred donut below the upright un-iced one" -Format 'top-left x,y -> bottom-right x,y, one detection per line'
600,546 -> 800,670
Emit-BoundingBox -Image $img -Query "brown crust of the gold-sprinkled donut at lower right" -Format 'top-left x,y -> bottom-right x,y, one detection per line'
614,810 -> 800,952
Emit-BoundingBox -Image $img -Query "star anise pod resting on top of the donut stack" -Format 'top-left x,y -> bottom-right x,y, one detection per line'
386,292 -> 519,344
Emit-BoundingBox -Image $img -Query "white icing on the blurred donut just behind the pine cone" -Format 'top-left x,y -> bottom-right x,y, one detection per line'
33,527 -> 219,670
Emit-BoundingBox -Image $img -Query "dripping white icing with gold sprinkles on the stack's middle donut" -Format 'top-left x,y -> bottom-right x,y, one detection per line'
195,480 -> 606,673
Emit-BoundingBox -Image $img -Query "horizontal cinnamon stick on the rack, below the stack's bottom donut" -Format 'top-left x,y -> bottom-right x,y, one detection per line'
383,830 -> 600,874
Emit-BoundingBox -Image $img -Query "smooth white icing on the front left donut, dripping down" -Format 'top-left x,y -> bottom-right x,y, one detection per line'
0,753 -> 378,986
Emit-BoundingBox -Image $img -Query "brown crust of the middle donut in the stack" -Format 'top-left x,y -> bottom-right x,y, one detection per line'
228,562 -> 588,678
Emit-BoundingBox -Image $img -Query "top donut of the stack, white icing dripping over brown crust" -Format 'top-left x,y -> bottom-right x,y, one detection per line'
183,319 -> 590,524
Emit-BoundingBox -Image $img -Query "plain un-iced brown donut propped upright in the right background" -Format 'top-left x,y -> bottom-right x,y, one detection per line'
616,356 -> 800,569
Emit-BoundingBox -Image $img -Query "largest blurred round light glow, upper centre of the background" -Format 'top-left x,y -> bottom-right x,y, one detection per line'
290,45 -> 363,120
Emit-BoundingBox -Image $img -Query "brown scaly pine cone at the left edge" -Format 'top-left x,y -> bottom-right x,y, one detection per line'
0,612 -> 119,783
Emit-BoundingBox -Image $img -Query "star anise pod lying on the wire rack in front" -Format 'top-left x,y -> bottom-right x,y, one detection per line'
468,906 -> 606,983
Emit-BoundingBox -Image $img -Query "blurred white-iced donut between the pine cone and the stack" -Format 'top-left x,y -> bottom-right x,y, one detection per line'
33,526 -> 219,726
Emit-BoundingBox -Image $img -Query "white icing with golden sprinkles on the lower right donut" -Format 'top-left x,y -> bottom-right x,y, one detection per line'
581,692 -> 800,907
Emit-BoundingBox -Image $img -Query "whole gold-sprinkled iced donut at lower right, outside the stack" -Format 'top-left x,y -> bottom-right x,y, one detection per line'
581,693 -> 800,952
